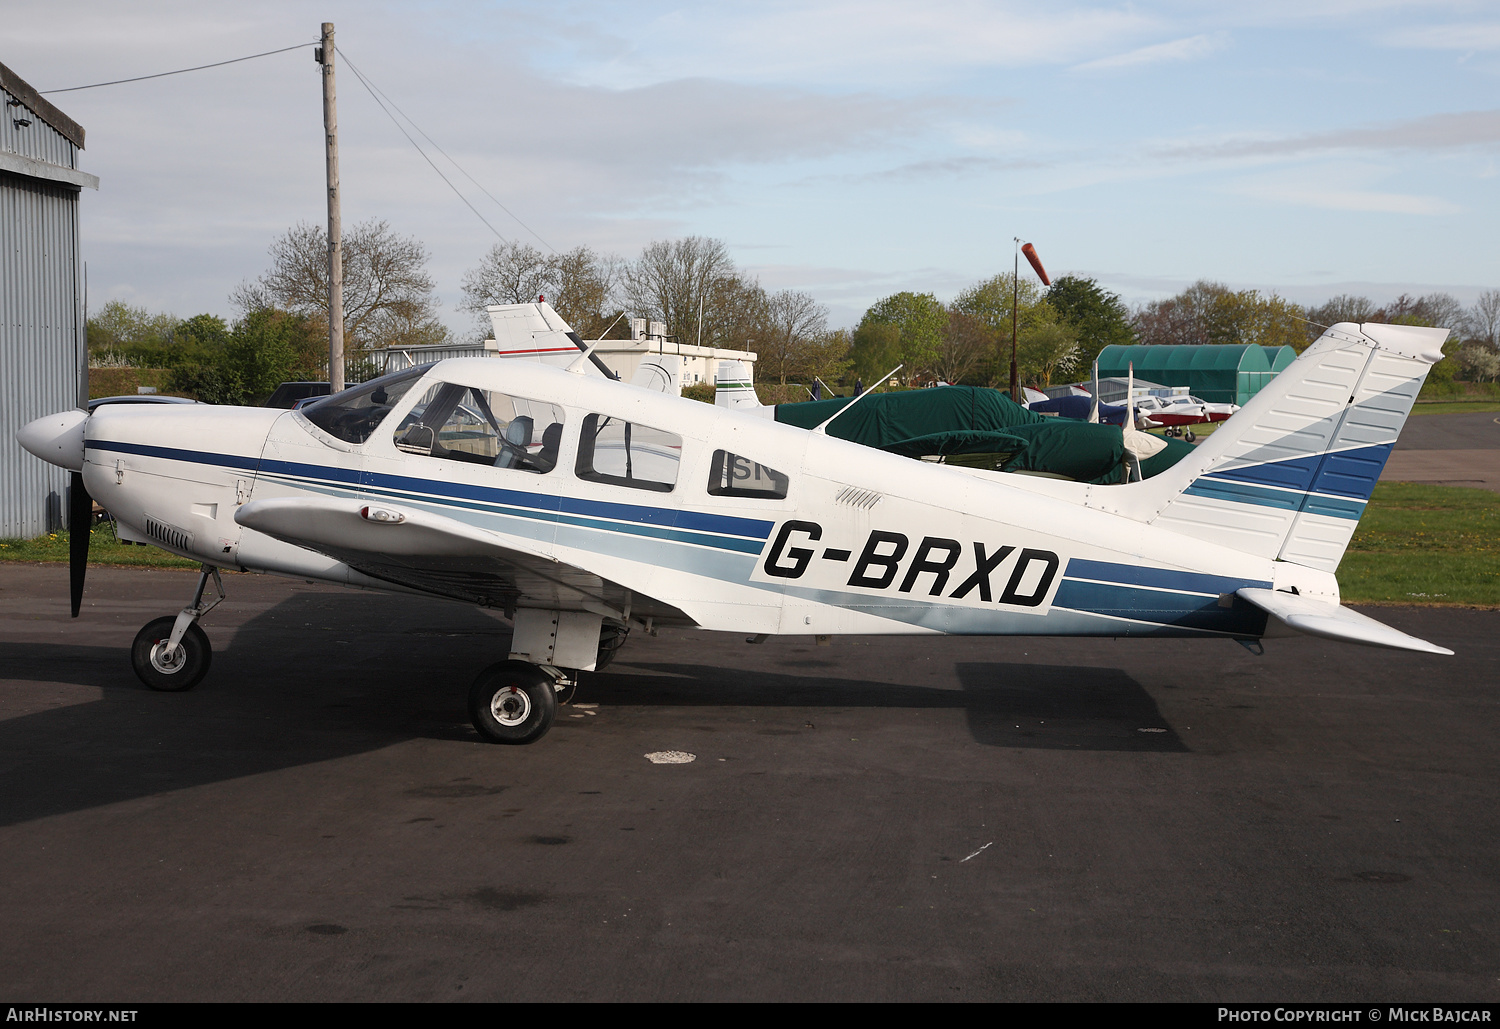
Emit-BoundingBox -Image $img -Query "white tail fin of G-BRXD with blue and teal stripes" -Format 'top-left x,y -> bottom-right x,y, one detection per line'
1116,323 -> 1448,572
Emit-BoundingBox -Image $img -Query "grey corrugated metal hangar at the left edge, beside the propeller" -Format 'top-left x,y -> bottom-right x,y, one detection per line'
0,65 -> 99,537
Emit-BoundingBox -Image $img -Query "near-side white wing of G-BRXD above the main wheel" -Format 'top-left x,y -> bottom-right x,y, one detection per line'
234,498 -> 695,626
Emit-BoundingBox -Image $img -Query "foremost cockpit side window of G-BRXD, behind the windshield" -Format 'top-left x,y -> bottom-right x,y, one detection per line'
395,383 -> 563,474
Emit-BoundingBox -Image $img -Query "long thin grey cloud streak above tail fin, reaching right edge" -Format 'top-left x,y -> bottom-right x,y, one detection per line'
1158,108 -> 1500,158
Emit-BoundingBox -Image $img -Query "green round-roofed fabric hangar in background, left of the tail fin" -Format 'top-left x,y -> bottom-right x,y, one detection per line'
1100,344 -> 1298,405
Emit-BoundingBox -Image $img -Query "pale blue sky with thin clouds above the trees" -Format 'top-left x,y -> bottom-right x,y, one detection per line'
11,0 -> 1500,332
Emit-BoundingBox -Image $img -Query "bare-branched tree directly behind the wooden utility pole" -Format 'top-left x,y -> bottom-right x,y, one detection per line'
230,219 -> 447,351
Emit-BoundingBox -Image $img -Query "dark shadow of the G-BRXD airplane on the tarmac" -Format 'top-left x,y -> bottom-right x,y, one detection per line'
0,593 -> 1187,825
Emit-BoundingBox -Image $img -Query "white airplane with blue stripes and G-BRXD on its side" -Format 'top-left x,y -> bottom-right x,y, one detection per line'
18,305 -> 1452,743
